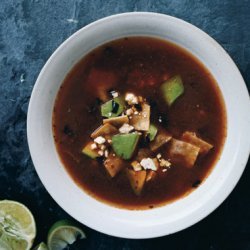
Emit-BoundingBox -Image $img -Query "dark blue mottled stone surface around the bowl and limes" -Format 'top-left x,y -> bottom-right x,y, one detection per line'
0,0 -> 250,250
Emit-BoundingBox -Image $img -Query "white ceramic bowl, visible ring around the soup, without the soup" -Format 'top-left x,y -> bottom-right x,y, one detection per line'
27,12 -> 250,238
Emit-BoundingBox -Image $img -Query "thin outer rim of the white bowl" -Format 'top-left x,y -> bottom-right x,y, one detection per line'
27,12 -> 250,239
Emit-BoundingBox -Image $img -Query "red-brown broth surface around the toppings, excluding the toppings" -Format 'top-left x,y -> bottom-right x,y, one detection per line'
53,37 -> 226,209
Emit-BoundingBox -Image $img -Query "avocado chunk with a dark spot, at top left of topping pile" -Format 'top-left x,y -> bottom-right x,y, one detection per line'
101,96 -> 125,118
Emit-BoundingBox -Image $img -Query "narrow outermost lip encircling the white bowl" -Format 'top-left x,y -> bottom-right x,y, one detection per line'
27,12 -> 250,239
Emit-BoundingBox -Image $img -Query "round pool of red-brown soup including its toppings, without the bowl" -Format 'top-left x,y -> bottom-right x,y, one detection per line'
53,37 -> 226,209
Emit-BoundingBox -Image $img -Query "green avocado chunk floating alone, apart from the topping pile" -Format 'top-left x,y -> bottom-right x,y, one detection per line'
161,75 -> 184,106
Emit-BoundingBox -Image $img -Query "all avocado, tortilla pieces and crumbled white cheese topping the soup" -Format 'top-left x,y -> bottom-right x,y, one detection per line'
82,81 -> 213,195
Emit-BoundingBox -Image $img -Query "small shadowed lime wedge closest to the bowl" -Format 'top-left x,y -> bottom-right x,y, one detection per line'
47,220 -> 86,250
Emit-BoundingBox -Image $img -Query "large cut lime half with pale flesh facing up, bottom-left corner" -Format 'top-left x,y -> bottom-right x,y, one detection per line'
0,200 -> 36,250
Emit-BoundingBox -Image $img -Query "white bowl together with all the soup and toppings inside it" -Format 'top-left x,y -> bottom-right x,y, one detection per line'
28,13 -> 250,238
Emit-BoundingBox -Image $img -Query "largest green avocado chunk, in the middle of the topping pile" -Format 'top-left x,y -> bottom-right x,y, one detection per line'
112,133 -> 140,160
